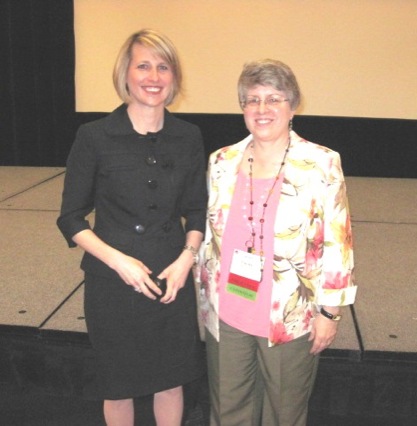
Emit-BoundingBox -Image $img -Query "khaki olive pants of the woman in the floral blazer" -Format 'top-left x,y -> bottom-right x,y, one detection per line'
206,322 -> 318,426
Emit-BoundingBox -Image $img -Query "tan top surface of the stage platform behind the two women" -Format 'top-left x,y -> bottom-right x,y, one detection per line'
0,167 -> 417,356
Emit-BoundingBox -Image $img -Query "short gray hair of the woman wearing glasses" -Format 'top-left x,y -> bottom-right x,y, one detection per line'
238,59 -> 301,111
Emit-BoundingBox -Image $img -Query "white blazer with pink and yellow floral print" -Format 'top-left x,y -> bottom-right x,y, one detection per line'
199,131 -> 357,346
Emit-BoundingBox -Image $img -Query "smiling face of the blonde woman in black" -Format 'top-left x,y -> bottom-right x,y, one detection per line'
126,43 -> 174,109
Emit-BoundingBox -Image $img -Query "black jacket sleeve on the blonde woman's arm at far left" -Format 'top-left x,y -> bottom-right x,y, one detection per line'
57,126 -> 97,247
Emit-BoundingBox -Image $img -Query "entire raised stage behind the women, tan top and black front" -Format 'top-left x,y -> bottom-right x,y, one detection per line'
0,167 -> 417,426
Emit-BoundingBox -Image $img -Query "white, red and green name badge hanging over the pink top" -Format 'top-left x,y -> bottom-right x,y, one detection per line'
226,249 -> 262,301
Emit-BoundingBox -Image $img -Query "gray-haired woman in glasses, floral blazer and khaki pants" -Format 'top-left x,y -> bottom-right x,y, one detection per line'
200,59 -> 356,426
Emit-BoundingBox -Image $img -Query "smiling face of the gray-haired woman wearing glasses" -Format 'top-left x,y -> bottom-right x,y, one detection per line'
243,85 -> 294,142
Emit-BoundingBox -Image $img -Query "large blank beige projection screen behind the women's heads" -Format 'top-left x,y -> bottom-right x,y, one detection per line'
74,0 -> 417,119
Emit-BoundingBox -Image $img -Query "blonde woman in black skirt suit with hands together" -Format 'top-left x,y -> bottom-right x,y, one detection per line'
58,29 -> 207,426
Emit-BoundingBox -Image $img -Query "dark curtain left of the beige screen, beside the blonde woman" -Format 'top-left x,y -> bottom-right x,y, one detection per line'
0,0 -> 75,166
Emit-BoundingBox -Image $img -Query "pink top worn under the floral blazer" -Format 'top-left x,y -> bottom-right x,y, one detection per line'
219,172 -> 284,338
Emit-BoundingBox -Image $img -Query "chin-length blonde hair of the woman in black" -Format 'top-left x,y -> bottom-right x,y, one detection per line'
113,29 -> 182,105
